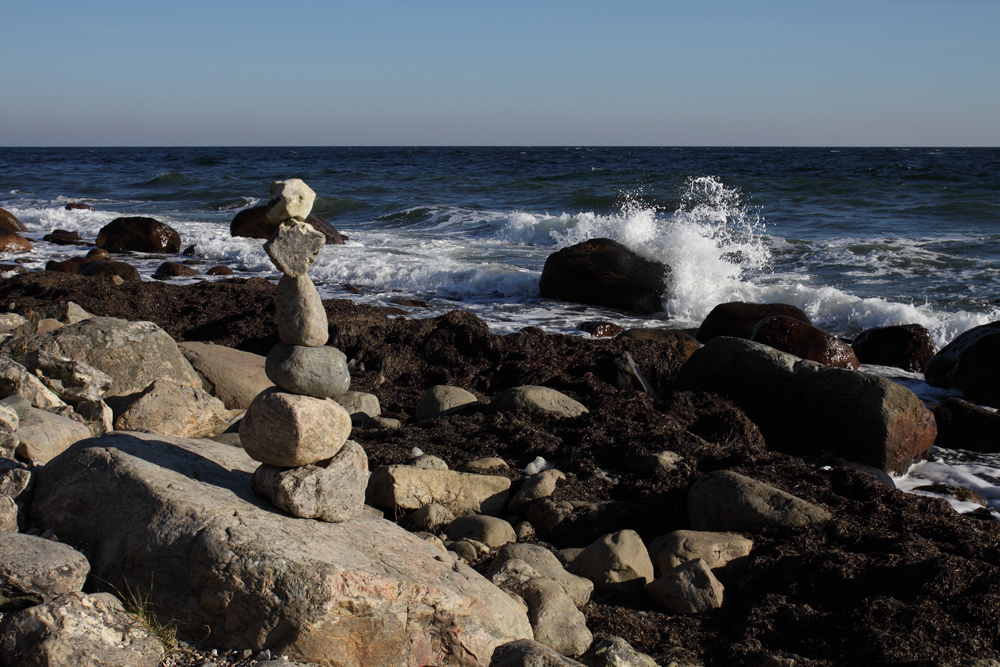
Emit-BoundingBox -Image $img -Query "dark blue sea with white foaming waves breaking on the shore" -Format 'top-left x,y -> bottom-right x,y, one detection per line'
0,146 -> 1000,519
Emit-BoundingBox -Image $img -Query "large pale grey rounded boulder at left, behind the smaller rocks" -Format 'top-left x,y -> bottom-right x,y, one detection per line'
0,317 -> 201,398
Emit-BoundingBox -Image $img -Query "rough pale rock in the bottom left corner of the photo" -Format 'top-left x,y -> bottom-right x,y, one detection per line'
0,592 -> 164,667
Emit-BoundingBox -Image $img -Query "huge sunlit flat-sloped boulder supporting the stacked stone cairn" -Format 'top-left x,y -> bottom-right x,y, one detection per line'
33,433 -> 531,667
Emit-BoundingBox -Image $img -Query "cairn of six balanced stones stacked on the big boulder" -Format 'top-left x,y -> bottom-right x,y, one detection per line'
240,179 -> 368,523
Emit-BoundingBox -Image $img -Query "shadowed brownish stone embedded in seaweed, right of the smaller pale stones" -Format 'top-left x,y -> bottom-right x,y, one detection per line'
687,470 -> 831,532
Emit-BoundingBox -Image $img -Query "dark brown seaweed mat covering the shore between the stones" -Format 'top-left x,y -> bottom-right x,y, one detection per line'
0,273 -> 1000,666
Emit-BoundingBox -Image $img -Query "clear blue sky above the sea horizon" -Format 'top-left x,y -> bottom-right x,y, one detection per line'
0,0 -> 1000,146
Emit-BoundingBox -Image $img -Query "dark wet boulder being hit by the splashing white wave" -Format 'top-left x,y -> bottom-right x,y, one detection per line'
538,238 -> 670,313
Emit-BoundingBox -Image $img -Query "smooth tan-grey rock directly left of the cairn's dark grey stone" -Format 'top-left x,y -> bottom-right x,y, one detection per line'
177,341 -> 274,410
